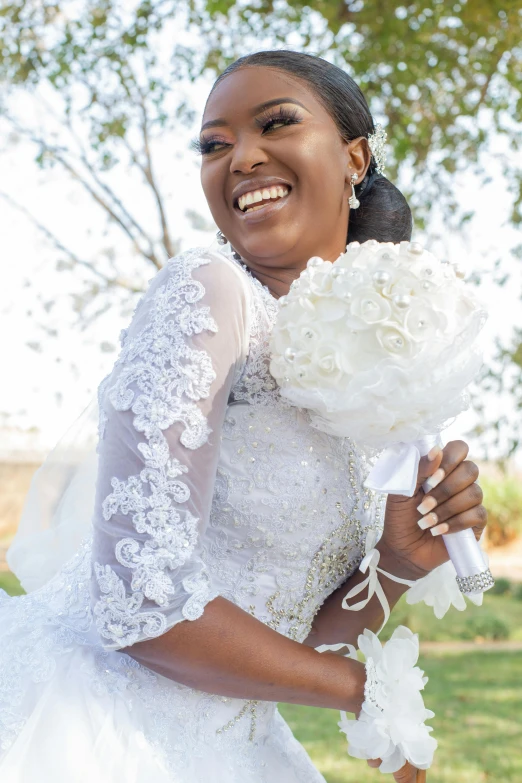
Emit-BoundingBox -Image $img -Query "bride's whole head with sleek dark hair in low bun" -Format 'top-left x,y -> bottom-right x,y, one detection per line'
192,51 -> 412,296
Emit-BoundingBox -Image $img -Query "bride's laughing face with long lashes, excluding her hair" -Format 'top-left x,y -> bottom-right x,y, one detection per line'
200,66 -> 370,279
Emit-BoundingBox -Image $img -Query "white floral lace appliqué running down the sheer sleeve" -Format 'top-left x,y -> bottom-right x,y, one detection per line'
94,251 -> 217,646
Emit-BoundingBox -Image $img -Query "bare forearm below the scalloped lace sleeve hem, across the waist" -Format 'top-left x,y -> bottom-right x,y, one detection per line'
125,596 -> 366,713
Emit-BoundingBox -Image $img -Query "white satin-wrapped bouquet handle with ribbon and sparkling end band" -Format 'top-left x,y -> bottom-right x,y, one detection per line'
365,435 -> 495,594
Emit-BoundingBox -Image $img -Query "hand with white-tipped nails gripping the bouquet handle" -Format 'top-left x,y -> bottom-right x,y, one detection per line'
377,440 -> 487,579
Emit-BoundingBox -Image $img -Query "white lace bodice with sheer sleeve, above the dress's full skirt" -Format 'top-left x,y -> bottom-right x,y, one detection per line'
91,242 -> 381,649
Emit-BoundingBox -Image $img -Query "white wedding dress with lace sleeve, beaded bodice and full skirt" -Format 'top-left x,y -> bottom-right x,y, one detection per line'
0,246 -> 382,783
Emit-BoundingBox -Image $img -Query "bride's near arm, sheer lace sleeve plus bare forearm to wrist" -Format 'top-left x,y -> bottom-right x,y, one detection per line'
91,251 -> 365,710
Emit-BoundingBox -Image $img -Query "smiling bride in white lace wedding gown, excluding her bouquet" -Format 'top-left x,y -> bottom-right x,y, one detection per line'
0,51 -> 485,783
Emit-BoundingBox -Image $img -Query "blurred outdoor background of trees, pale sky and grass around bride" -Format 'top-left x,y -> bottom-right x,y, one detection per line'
0,0 -> 522,783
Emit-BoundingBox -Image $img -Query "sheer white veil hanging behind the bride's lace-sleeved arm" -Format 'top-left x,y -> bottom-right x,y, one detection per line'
6,398 -> 98,592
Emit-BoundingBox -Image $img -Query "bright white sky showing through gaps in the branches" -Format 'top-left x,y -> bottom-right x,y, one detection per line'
0,66 -> 522,466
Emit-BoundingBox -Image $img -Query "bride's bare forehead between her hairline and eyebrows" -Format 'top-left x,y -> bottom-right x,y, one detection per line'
202,66 -> 328,122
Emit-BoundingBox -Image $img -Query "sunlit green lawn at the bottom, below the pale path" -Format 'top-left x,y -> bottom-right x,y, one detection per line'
279,652 -> 522,783
